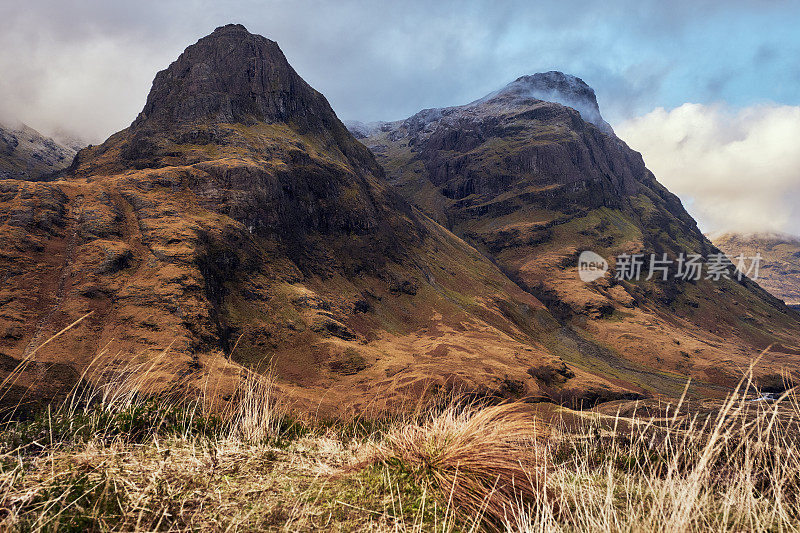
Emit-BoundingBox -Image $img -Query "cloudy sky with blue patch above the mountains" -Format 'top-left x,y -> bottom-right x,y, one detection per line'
0,0 -> 800,234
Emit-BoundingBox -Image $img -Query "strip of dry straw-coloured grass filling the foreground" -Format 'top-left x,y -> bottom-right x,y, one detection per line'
0,368 -> 800,532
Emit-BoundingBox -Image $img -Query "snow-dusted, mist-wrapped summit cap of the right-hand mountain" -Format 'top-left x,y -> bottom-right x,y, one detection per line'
479,71 -> 614,134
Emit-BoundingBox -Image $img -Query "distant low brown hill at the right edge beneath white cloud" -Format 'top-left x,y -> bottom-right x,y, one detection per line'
713,233 -> 800,307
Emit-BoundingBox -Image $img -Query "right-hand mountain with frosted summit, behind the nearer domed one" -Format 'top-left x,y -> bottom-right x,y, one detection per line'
355,73 -> 800,392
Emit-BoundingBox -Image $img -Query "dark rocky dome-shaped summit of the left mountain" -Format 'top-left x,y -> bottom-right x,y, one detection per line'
133,24 -> 333,129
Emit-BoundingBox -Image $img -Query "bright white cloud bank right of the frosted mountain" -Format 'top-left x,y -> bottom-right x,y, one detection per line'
614,103 -> 800,234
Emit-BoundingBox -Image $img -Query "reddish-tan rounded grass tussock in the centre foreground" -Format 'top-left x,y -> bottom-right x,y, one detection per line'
375,404 -> 546,525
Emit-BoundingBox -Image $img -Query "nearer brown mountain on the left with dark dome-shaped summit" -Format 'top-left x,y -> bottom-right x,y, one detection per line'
0,25 -> 648,413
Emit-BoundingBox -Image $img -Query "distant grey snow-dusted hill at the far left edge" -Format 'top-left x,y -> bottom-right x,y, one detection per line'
0,124 -> 77,180
